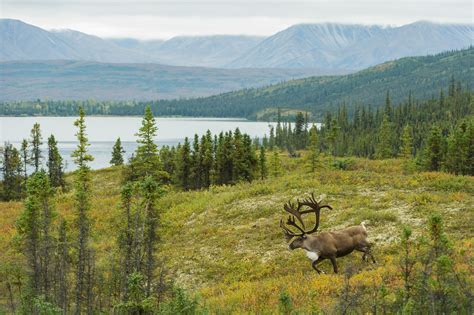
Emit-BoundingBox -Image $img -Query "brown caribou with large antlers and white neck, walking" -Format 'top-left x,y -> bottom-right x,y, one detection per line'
280,194 -> 375,273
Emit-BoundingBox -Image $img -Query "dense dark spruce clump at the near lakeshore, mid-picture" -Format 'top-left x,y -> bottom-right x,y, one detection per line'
160,128 -> 267,190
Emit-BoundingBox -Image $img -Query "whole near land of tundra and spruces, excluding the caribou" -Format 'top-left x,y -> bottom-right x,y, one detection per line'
0,81 -> 474,314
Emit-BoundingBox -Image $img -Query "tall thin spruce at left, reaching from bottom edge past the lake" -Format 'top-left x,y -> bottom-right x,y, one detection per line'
72,107 -> 94,314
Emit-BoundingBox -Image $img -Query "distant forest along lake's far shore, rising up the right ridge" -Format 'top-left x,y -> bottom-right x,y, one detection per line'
0,47 -> 474,119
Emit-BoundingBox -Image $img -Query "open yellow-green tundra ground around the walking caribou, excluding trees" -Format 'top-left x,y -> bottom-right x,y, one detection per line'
0,155 -> 474,313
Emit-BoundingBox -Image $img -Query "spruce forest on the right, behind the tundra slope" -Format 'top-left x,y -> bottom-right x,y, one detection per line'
263,79 -> 474,175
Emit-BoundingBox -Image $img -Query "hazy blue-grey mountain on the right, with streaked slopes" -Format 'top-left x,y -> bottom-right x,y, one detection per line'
228,22 -> 474,70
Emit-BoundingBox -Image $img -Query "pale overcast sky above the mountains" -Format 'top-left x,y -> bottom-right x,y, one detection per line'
0,0 -> 473,39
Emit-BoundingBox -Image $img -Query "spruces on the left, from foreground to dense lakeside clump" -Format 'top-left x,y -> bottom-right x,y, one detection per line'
2,107 -> 267,314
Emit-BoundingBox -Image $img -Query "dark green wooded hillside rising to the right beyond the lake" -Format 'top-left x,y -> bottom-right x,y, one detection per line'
146,48 -> 474,118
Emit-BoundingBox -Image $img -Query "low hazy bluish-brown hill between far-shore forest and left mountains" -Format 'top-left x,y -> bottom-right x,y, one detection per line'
0,60 -> 325,101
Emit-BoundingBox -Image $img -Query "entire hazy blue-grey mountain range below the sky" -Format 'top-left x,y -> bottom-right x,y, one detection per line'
0,19 -> 474,72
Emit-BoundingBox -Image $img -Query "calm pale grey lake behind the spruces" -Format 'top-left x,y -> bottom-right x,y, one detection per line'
0,117 -> 280,171
